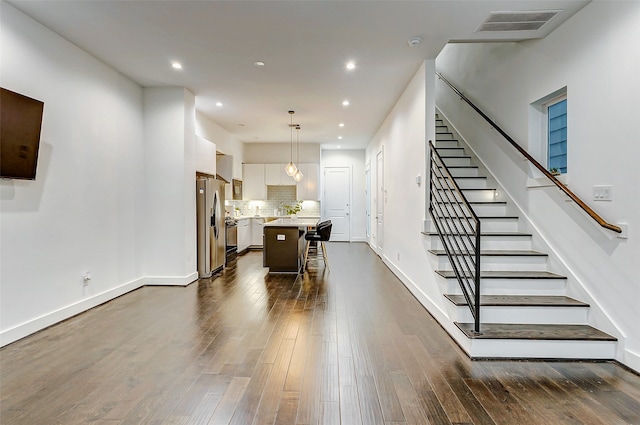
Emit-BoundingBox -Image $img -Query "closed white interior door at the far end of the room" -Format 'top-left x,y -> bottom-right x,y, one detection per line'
322,167 -> 351,242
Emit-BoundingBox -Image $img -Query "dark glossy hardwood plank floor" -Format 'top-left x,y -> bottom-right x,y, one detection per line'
0,243 -> 640,425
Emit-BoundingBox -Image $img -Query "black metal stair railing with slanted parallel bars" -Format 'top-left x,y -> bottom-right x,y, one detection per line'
429,140 -> 481,333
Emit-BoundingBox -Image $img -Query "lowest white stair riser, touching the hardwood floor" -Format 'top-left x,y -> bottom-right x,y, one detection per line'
468,336 -> 616,360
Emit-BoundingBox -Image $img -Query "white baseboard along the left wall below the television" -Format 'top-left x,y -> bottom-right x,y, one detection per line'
0,278 -> 145,347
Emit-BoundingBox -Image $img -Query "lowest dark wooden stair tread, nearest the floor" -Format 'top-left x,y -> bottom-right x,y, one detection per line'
454,322 -> 617,341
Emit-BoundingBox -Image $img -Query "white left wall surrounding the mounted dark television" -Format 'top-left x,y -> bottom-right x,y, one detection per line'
0,2 -> 144,345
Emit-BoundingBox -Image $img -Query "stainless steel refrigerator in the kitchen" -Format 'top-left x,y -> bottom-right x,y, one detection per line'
196,177 -> 226,277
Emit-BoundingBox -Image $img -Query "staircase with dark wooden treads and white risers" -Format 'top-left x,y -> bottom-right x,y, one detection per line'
426,115 -> 616,359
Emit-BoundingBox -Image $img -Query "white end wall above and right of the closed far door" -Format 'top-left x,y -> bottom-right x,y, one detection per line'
320,149 -> 367,242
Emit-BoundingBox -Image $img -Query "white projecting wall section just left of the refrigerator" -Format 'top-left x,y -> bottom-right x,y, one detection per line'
144,87 -> 197,284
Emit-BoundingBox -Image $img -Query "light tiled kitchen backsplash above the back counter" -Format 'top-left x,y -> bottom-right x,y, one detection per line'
225,186 -> 320,217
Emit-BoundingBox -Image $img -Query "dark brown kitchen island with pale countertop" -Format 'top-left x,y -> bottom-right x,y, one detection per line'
262,218 -> 319,273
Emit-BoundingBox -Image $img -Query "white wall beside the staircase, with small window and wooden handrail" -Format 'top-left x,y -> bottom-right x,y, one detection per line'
437,1 -> 640,370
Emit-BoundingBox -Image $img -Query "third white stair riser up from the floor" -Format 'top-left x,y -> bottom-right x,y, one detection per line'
442,278 -> 566,295
